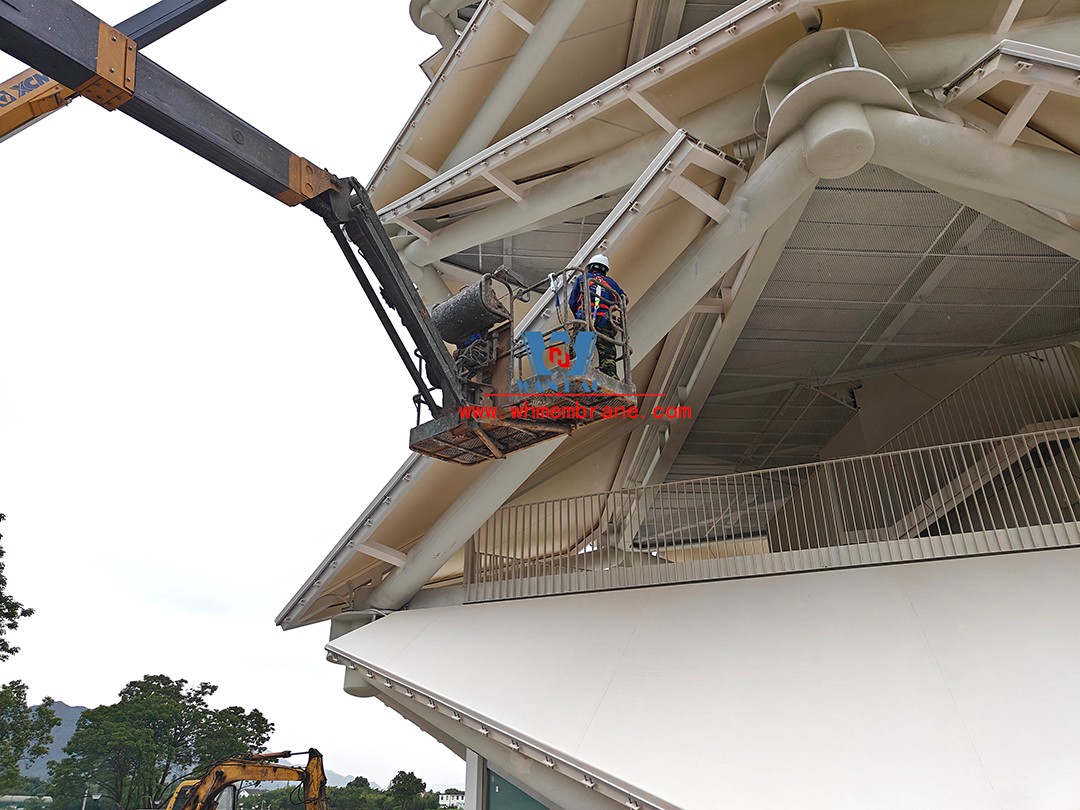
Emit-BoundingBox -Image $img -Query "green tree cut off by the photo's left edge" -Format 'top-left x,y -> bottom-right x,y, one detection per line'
0,514 -> 59,794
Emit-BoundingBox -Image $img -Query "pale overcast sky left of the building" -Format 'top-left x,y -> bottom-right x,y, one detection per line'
0,0 -> 464,787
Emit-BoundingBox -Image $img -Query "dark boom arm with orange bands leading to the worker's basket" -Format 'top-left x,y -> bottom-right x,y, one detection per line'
0,0 -> 465,416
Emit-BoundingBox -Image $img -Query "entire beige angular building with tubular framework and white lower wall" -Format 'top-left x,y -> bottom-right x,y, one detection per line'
278,0 -> 1080,810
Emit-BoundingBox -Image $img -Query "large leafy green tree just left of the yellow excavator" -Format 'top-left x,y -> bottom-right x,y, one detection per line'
50,675 -> 273,810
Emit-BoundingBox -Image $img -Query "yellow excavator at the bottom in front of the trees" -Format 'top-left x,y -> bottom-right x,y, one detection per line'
164,748 -> 328,810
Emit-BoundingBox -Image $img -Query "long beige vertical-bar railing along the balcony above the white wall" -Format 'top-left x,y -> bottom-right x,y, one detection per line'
464,418 -> 1080,602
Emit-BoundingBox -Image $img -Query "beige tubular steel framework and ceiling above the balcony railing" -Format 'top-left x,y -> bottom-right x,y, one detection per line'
279,0 -> 1080,627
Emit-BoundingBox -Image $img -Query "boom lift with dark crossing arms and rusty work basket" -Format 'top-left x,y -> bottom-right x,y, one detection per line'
0,0 -> 635,464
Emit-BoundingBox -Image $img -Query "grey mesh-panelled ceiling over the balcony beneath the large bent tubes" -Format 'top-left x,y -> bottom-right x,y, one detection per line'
669,166 -> 1080,480
